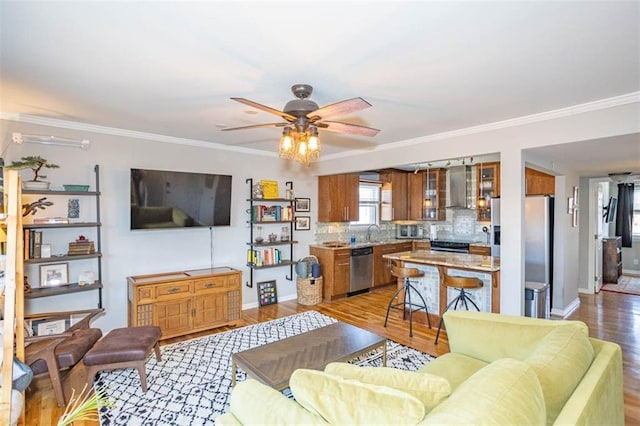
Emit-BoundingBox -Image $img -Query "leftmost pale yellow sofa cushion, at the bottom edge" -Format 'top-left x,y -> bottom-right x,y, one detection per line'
225,379 -> 326,425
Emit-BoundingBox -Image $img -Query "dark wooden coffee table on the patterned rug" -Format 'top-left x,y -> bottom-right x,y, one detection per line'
231,322 -> 387,390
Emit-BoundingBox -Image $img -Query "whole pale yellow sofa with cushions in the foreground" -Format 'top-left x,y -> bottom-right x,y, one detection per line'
216,311 -> 624,426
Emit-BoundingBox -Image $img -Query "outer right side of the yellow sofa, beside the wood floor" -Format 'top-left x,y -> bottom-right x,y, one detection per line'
554,338 -> 624,425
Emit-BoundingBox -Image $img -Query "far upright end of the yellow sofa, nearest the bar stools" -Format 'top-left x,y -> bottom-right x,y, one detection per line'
444,311 -> 589,362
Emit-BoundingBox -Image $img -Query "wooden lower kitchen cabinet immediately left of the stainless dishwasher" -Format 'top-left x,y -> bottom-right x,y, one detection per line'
309,246 -> 351,300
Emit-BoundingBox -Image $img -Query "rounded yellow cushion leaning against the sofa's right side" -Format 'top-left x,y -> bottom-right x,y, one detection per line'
525,327 -> 594,424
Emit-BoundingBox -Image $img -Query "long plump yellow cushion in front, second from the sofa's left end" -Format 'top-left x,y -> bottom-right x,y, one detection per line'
289,369 -> 425,425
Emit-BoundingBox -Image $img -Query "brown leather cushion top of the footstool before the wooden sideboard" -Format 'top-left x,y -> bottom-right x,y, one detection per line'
84,326 -> 161,365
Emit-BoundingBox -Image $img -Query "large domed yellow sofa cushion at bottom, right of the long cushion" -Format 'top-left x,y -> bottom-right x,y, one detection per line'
422,358 -> 546,425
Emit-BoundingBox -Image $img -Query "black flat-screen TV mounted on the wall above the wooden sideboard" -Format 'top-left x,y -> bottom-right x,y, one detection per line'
131,169 -> 231,229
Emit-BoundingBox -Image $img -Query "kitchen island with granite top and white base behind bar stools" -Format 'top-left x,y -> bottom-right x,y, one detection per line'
384,250 -> 500,320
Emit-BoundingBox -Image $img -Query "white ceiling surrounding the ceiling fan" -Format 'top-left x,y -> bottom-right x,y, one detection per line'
0,1 -> 640,176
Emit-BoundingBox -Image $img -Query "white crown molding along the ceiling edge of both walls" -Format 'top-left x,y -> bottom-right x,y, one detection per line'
0,92 -> 640,161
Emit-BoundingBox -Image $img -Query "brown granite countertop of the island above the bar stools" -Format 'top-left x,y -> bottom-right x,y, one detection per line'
383,250 -> 500,272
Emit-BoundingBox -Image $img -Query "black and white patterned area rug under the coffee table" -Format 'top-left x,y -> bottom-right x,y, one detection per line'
95,311 -> 433,426
